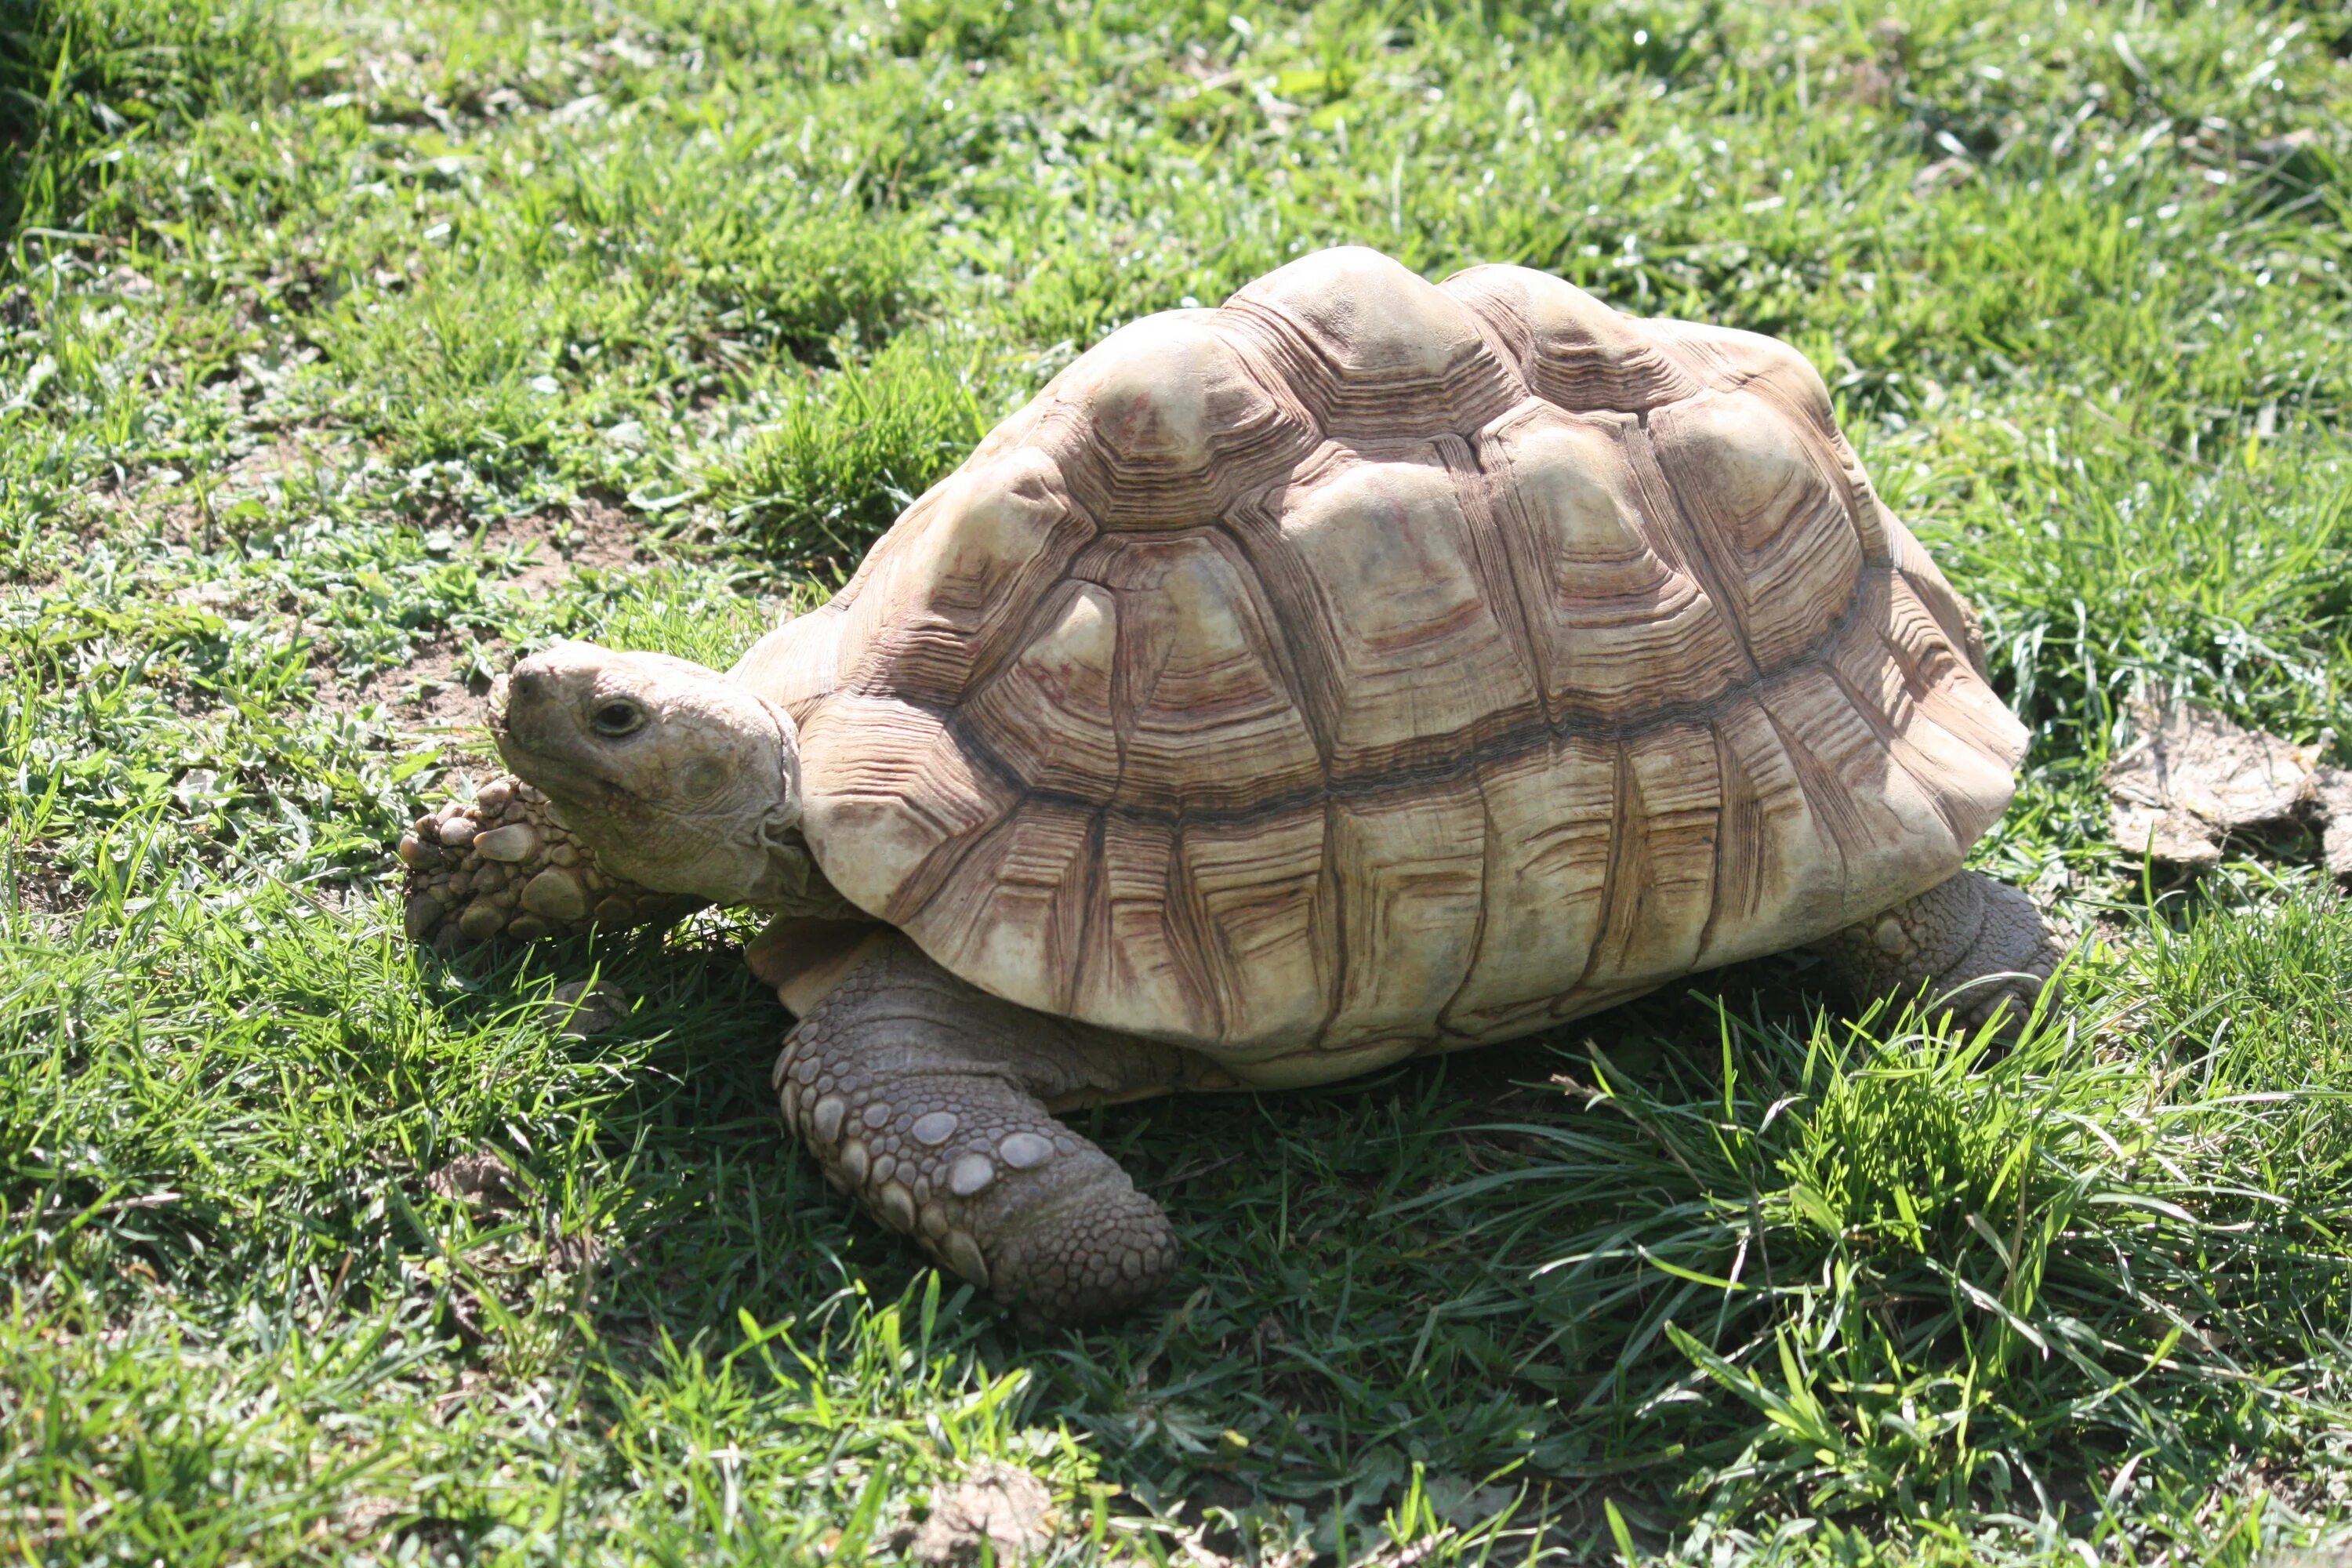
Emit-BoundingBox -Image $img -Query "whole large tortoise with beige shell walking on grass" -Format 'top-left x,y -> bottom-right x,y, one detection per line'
402,249 -> 2060,1323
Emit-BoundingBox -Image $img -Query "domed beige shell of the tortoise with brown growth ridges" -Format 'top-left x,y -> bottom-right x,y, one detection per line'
736,249 -> 2025,1083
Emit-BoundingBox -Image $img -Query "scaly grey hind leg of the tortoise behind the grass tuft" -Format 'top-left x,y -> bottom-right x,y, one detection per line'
1816,872 -> 2065,1029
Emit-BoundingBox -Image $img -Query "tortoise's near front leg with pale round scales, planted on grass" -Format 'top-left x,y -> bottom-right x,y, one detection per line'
774,933 -> 1211,1323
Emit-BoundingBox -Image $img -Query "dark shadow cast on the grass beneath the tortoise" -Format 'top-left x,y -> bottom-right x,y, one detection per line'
405,921 -> 1759,1544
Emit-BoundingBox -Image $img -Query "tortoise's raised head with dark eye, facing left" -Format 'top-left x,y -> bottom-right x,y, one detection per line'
489,642 -> 800,905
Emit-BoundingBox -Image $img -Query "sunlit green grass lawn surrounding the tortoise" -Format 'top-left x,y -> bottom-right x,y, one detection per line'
0,0 -> 2352,1568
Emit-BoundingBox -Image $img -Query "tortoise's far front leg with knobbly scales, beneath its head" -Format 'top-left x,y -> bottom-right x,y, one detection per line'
400,779 -> 703,952
